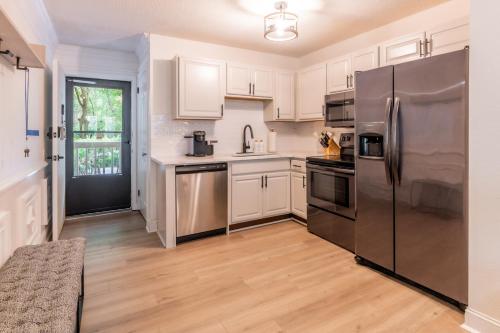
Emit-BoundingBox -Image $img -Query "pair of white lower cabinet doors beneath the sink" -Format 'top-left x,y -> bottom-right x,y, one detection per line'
231,171 -> 290,223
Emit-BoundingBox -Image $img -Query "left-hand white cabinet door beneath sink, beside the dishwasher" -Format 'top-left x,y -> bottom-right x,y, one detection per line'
231,174 -> 263,223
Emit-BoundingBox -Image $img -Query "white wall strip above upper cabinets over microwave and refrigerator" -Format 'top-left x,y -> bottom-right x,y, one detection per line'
300,0 -> 470,67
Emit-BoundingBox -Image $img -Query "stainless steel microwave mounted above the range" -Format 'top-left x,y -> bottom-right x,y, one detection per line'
325,90 -> 354,127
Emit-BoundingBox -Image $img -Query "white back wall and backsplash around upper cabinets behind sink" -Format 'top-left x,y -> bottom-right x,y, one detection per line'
150,35 -> 332,155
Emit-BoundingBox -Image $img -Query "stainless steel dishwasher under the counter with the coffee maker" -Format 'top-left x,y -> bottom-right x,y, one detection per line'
175,163 -> 228,243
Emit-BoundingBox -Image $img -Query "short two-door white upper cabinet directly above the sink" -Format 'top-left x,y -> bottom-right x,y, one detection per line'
227,63 -> 273,98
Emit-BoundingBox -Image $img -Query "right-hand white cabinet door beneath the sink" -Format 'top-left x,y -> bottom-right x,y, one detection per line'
262,171 -> 290,217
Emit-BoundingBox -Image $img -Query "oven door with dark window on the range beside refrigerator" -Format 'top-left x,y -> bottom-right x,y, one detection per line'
307,163 -> 356,220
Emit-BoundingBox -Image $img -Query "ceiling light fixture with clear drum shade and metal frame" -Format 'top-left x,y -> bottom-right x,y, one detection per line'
264,1 -> 298,42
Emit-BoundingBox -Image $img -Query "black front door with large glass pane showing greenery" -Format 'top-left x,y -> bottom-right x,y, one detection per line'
66,77 -> 131,216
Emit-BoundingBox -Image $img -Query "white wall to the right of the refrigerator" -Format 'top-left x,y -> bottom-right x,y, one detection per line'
466,0 -> 500,333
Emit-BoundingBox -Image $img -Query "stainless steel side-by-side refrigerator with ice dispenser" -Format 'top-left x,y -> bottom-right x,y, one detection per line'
355,49 -> 468,304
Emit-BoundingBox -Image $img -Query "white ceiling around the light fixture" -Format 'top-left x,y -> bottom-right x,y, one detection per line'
44,0 -> 447,56
